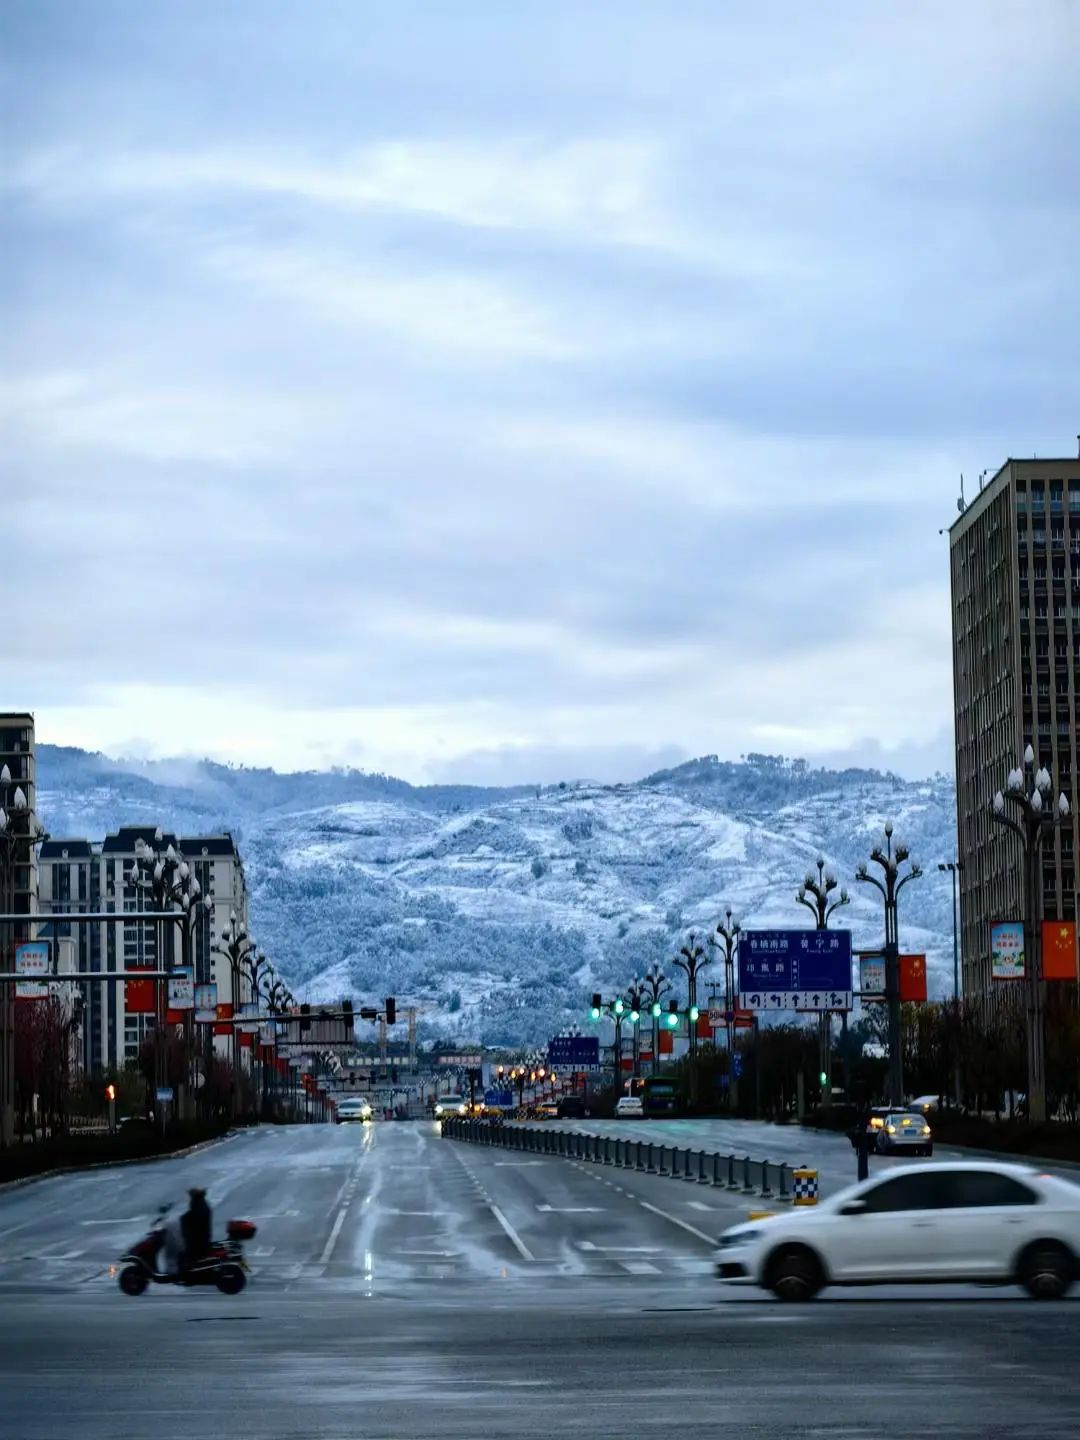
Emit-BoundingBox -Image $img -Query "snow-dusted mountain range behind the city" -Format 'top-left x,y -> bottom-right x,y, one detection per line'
37,744 -> 955,1043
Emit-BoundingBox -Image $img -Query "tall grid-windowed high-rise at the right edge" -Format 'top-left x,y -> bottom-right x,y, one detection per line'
949,459 -> 1080,998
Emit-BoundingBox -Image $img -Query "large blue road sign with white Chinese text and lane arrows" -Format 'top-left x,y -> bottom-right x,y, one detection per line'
739,930 -> 851,1009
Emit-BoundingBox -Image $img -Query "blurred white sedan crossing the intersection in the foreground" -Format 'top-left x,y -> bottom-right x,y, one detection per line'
716,1161 -> 1080,1300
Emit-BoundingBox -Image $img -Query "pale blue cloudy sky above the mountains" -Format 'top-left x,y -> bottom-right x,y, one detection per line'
0,0 -> 1080,780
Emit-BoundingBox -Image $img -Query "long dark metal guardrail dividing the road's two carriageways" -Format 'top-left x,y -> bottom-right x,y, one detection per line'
441,1119 -> 801,1205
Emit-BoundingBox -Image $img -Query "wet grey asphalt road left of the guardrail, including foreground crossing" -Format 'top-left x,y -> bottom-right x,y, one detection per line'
0,1123 -> 1080,1440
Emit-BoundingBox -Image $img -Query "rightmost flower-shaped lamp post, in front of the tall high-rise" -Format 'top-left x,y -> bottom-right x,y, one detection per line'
991,746 -> 1068,1125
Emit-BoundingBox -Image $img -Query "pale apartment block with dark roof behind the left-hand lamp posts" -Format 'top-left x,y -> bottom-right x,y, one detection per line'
39,825 -> 248,1074
